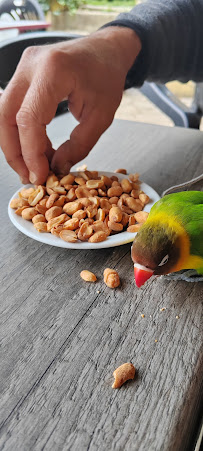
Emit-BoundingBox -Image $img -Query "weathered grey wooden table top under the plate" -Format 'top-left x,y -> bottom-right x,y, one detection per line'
0,116 -> 203,451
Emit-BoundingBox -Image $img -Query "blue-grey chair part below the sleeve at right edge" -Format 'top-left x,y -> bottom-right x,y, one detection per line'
140,82 -> 203,128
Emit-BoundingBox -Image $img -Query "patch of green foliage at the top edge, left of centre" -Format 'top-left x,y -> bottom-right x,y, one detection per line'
38,0 -> 86,14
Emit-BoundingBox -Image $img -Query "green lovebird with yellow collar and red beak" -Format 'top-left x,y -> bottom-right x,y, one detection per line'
131,191 -> 203,287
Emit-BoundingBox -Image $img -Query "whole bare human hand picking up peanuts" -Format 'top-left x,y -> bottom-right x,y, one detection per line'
0,27 -> 141,184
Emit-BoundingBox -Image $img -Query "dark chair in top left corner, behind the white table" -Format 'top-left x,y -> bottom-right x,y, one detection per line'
0,0 -> 45,22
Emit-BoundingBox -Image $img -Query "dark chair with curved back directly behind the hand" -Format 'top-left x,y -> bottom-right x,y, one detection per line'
0,31 -> 81,115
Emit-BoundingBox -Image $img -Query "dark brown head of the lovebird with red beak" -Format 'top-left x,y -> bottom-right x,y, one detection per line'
131,222 -> 180,287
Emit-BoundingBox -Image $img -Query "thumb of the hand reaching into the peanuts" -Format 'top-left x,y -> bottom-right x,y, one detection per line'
51,110 -> 113,175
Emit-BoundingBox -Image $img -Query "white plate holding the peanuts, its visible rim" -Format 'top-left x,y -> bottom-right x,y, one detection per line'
8,171 -> 160,249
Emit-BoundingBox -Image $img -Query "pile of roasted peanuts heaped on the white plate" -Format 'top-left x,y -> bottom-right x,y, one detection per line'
10,169 -> 150,243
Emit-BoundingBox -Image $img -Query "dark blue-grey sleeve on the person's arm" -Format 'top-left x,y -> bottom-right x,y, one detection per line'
102,0 -> 203,87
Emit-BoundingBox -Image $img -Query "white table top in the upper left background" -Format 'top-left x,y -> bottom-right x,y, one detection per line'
0,20 -> 50,32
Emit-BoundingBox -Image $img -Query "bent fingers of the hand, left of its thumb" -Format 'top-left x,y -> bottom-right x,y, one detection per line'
0,49 -> 63,184
